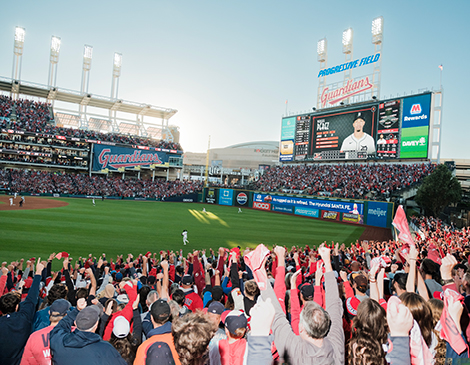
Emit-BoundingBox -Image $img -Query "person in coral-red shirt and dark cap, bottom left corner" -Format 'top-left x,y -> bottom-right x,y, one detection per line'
21,299 -> 71,365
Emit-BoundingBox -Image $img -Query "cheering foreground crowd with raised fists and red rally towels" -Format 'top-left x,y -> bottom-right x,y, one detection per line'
0,213 -> 470,365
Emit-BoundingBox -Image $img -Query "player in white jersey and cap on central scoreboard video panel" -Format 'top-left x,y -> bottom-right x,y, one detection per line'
310,105 -> 377,160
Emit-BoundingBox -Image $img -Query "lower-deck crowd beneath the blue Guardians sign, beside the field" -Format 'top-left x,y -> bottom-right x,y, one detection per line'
0,170 -> 202,199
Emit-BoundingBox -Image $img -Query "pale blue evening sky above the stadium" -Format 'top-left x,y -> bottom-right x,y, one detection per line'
0,0 -> 470,158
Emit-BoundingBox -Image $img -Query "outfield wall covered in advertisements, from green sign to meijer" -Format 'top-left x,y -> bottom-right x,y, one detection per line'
202,188 -> 394,228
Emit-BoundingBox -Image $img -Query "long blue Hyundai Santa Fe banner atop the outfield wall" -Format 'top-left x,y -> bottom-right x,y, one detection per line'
253,193 -> 364,215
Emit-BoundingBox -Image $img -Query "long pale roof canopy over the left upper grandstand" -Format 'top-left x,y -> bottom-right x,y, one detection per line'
0,77 -> 178,120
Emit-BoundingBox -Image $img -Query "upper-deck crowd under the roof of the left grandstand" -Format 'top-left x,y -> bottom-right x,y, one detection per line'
0,95 -> 182,151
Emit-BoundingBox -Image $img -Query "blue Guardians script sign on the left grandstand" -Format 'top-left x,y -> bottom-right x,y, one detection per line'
93,144 -> 176,171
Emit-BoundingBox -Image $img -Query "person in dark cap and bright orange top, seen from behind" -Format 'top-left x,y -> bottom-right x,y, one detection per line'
134,299 -> 181,365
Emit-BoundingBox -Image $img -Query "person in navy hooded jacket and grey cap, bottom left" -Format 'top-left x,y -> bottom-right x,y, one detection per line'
50,298 -> 127,365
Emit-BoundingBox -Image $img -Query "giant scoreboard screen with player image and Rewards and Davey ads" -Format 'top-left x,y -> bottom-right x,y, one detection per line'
279,93 -> 431,162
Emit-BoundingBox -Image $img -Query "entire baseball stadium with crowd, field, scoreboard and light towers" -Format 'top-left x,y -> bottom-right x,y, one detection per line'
0,3 -> 470,365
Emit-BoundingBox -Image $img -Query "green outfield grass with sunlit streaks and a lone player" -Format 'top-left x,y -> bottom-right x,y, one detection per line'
0,198 -> 364,266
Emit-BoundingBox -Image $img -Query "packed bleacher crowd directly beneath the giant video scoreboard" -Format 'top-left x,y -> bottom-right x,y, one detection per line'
255,163 -> 435,200
